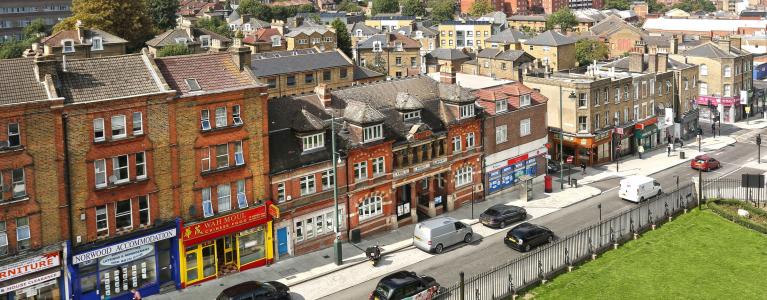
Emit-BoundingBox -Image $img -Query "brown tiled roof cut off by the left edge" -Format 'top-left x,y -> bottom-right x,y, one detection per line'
0,58 -> 48,105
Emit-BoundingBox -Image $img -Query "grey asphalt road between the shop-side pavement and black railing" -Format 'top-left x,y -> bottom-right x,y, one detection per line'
323,124 -> 767,299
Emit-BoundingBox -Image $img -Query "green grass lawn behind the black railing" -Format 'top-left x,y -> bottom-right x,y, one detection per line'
526,210 -> 767,299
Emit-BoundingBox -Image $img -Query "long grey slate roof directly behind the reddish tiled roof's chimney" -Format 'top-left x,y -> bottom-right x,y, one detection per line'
251,49 -> 353,77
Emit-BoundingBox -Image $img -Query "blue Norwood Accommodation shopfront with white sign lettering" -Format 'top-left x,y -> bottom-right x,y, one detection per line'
67,219 -> 181,300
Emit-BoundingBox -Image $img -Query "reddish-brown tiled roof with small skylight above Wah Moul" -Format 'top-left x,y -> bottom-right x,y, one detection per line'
155,52 -> 258,96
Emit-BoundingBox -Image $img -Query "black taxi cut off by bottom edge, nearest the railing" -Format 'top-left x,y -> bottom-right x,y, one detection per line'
370,271 -> 439,300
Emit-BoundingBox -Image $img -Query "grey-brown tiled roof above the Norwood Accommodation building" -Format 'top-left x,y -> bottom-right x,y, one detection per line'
56,54 -> 166,103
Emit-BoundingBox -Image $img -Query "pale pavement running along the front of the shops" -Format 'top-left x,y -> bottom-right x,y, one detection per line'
147,137 -> 736,299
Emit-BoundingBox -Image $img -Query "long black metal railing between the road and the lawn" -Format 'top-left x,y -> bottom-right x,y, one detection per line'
434,184 -> 697,300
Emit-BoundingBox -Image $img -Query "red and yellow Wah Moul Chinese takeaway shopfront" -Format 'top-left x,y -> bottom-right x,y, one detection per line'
180,202 -> 279,286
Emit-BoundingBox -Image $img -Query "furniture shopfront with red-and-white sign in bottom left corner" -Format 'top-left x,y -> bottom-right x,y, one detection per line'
0,250 -> 65,300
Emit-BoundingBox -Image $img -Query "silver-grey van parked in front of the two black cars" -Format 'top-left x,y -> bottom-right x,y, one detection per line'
413,217 -> 474,254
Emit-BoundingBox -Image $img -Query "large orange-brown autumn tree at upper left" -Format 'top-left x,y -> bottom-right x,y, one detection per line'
53,0 -> 154,51
